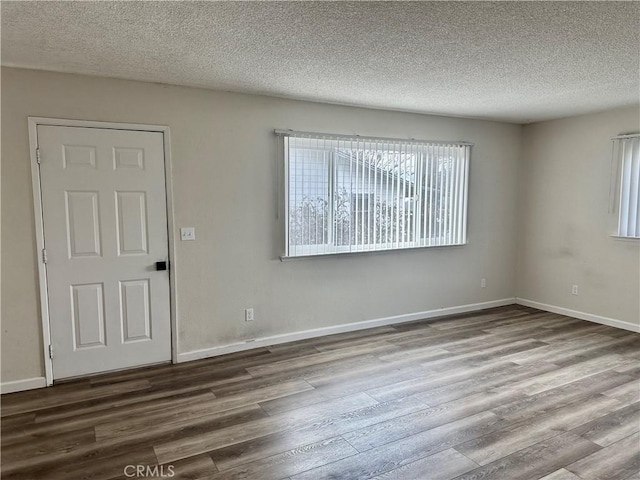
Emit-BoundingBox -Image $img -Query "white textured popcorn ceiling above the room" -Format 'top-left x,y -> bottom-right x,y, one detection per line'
1,1 -> 640,123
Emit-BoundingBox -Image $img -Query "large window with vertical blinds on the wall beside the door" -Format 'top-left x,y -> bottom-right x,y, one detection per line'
278,132 -> 470,257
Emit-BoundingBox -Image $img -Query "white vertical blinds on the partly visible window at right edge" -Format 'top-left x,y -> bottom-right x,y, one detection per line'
613,135 -> 640,238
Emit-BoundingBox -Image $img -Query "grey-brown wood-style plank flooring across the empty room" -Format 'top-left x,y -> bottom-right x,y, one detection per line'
1,305 -> 640,480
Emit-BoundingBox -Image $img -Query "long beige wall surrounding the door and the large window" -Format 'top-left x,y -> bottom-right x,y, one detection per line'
1,68 -> 521,381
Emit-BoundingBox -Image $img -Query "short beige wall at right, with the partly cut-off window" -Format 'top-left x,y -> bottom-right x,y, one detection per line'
518,108 -> 640,324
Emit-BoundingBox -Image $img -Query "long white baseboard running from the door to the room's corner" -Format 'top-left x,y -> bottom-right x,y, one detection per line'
178,298 -> 516,363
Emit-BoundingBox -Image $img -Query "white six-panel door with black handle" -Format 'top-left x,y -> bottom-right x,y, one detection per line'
37,125 -> 171,379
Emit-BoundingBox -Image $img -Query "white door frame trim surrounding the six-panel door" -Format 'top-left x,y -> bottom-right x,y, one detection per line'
28,117 -> 178,386
